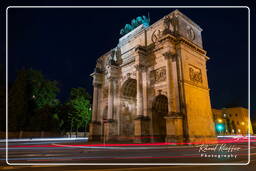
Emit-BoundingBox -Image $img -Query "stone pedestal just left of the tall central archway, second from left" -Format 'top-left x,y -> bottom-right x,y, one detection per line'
103,120 -> 117,142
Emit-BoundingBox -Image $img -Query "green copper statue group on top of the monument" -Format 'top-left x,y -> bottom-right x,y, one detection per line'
120,15 -> 150,36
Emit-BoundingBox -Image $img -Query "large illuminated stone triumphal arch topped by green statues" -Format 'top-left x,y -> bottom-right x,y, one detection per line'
89,10 -> 215,142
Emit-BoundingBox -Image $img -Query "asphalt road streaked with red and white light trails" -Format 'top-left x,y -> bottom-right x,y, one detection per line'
0,139 -> 256,171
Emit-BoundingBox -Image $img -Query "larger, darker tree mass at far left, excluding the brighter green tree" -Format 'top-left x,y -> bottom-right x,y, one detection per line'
8,69 -> 59,131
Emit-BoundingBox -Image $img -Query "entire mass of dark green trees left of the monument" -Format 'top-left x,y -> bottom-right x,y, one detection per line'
8,69 -> 92,135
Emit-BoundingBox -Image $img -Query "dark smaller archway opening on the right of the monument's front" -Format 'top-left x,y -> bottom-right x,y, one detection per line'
152,95 -> 168,141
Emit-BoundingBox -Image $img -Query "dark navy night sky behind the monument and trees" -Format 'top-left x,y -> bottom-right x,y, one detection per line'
3,8 -> 255,119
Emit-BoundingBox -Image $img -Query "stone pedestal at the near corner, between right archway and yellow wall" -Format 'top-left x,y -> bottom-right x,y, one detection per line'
165,113 -> 184,143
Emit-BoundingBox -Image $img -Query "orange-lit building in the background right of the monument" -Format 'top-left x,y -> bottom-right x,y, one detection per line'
212,107 -> 253,135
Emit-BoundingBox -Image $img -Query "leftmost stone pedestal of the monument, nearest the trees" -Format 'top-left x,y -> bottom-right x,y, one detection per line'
89,121 -> 101,141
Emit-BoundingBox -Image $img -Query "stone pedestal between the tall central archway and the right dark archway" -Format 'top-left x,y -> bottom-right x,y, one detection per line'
134,116 -> 150,143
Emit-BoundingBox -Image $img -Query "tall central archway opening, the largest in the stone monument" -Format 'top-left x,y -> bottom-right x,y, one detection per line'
120,78 -> 137,138
